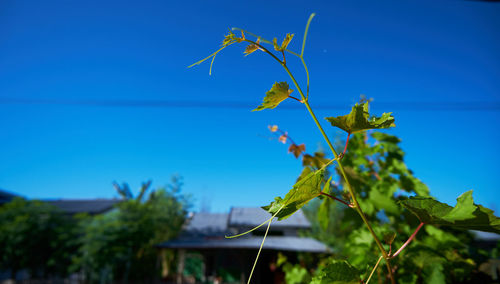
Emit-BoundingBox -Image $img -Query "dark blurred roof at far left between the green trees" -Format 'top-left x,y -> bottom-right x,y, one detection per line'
46,199 -> 122,214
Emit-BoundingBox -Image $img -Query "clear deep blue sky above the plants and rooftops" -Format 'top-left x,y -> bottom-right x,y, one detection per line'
0,0 -> 500,213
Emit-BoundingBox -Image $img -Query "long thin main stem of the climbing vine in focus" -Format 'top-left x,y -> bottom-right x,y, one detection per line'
282,64 -> 396,284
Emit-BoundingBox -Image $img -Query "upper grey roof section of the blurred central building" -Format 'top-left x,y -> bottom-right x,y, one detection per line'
228,207 -> 311,229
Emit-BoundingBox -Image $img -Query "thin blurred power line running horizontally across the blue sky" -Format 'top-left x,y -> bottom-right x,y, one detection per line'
0,98 -> 500,111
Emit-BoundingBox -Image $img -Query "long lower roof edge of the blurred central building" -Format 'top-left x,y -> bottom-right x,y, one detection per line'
158,236 -> 328,253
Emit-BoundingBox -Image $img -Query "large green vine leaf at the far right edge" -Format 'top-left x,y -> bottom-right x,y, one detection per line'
399,190 -> 500,234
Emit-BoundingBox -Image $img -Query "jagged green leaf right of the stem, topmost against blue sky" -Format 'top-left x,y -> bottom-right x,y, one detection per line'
326,102 -> 396,133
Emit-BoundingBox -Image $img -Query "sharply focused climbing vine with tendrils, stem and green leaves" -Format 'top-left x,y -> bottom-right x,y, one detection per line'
189,13 -> 500,284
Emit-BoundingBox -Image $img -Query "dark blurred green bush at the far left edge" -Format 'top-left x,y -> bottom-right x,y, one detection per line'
0,198 -> 75,278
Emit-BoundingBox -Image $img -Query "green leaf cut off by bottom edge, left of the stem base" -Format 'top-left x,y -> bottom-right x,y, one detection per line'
311,260 -> 360,284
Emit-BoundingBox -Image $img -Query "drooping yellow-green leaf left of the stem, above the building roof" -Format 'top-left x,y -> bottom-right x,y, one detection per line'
262,168 -> 324,221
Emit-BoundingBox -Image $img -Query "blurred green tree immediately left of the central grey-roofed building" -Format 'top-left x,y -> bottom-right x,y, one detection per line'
74,180 -> 188,283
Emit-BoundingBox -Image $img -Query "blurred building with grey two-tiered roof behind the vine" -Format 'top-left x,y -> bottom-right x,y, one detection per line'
158,208 -> 328,283
